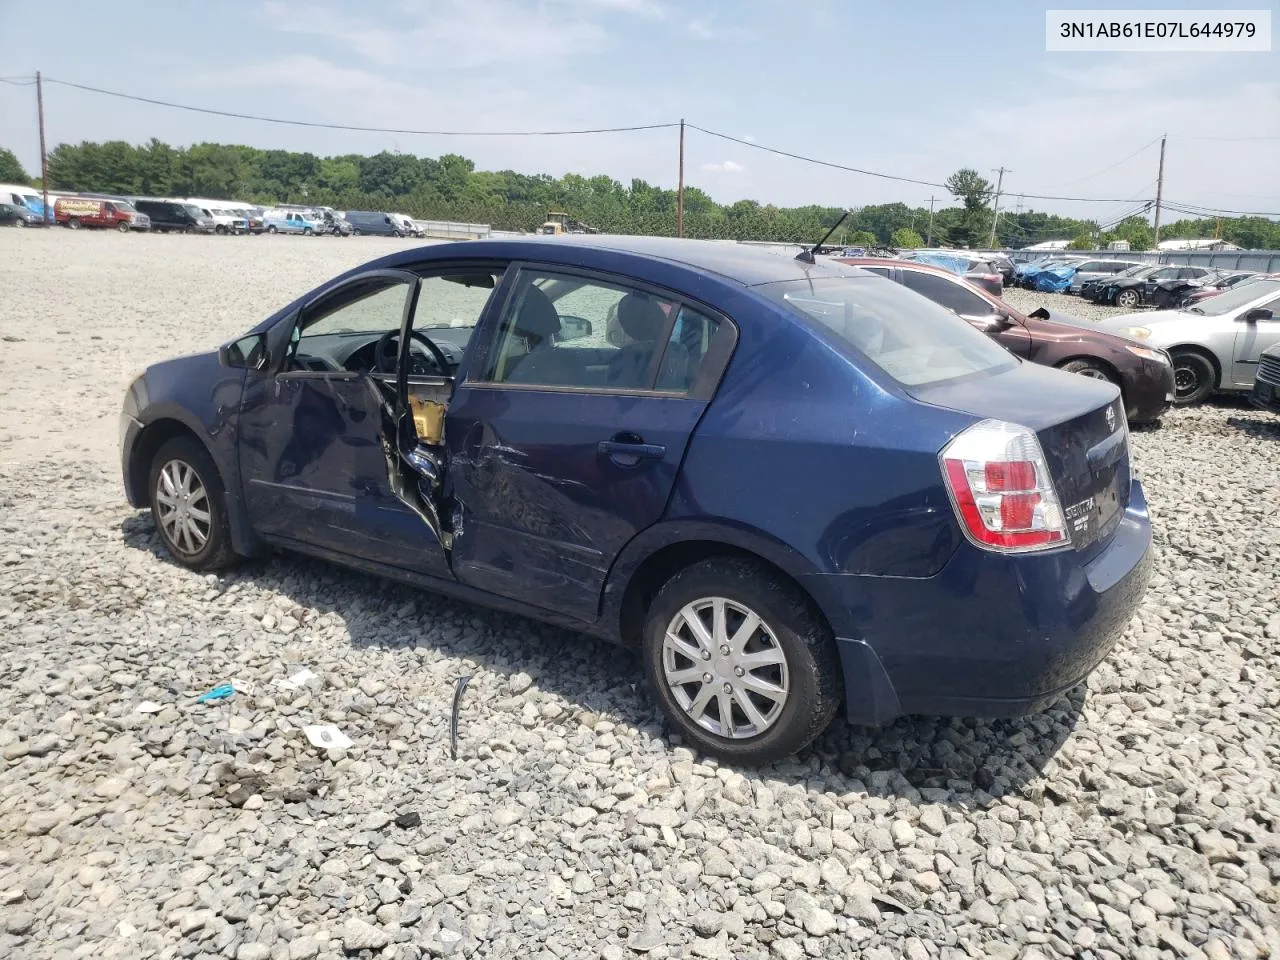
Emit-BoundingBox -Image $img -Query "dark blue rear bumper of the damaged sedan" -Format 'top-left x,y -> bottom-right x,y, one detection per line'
805,481 -> 1151,726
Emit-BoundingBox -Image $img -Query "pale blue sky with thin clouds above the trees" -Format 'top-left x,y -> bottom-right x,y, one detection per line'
0,0 -> 1280,216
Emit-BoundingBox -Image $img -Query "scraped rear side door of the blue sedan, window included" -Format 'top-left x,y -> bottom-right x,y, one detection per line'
445,266 -> 735,621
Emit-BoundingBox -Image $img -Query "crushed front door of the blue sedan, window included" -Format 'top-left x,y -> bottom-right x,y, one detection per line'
239,270 -> 449,576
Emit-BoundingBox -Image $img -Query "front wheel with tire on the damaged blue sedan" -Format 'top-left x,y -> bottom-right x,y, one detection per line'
147,436 -> 236,570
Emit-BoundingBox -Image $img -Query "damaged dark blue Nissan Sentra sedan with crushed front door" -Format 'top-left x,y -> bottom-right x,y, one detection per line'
120,237 -> 1151,764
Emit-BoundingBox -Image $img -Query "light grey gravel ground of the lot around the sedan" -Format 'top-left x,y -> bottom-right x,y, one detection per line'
0,230 -> 1280,960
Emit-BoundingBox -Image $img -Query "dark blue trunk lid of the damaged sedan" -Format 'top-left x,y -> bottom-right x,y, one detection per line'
911,364 -> 1132,557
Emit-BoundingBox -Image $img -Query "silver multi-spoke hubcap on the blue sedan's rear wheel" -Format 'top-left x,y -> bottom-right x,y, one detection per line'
662,596 -> 790,740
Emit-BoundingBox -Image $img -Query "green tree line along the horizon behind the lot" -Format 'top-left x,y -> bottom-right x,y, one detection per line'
0,138 -> 1280,250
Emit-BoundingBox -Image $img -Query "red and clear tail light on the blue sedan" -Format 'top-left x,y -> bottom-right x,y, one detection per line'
938,420 -> 1070,553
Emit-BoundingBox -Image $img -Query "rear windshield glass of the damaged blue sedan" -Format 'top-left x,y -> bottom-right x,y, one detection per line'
755,276 -> 1018,387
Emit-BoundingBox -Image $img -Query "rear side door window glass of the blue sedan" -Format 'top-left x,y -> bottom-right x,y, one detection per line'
486,270 -> 718,393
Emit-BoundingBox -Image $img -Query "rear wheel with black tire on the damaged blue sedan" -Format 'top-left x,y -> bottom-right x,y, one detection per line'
643,557 -> 844,765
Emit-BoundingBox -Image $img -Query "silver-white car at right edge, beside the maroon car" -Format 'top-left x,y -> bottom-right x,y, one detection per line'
1098,278 -> 1280,404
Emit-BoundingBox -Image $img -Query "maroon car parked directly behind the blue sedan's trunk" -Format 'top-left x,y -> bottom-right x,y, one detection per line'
836,257 -> 1174,422
